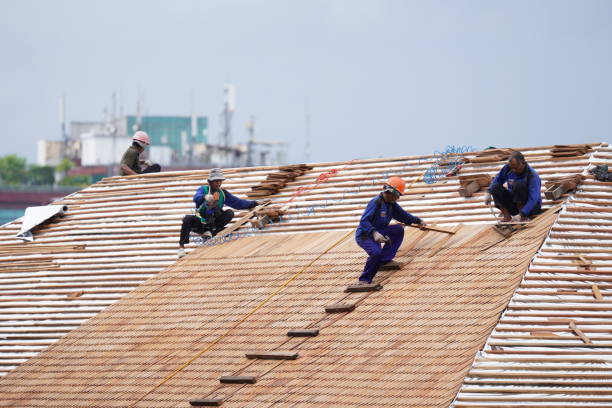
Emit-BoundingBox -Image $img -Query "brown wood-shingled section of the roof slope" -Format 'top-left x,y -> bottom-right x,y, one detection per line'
0,211 -> 557,407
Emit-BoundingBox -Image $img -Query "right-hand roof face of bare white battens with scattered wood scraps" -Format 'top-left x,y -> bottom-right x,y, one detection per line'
454,148 -> 612,408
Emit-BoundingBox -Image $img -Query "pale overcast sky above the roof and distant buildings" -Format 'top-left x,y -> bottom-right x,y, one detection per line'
0,0 -> 612,162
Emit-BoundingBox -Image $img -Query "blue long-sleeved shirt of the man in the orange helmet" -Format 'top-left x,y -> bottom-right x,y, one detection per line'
355,193 -> 421,238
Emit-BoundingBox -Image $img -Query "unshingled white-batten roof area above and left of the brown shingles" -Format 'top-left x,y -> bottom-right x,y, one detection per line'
0,144 -> 600,375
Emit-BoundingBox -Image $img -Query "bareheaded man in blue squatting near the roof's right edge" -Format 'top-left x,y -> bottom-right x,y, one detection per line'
485,152 -> 542,222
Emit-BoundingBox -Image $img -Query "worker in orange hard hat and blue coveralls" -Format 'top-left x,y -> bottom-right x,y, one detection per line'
355,176 -> 425,284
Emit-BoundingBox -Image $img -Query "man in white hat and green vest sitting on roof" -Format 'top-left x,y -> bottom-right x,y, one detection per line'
178,169 -> 259,258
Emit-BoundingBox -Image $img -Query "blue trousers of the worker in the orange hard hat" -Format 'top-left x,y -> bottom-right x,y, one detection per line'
355,224 -> 404,283
